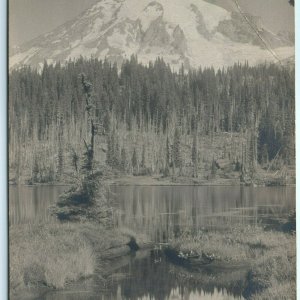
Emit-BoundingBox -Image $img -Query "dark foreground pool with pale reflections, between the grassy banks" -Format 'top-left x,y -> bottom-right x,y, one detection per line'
39,252 -> 243,300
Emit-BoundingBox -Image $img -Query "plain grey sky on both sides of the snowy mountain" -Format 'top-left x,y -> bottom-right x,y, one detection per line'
8,0 -> 294,46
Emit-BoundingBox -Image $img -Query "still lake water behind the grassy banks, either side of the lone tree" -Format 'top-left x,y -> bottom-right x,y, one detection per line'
9,186 -> 295,237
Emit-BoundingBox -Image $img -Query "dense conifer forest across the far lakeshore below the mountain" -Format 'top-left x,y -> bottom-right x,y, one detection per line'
8,56 -> 295,182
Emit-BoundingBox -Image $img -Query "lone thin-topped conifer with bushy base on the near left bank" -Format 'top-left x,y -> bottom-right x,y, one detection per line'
52,74 -> 111,224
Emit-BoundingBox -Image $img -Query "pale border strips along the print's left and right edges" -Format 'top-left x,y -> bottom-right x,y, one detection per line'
0,0 -> 300,299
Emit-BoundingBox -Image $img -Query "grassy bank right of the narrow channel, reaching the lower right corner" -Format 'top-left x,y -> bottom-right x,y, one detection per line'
172,227 -> 296,300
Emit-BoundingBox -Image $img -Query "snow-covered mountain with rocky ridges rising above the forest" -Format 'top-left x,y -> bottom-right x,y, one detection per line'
9,0 -> 294,69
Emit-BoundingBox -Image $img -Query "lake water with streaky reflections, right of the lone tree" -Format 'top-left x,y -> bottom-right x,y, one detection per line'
112,186 -> 294,241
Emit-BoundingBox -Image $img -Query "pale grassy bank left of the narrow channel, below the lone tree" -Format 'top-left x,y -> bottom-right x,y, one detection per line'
9,224 -> 149,297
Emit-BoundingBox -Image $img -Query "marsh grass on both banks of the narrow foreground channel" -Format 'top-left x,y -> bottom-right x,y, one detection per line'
9,223 -> 296,300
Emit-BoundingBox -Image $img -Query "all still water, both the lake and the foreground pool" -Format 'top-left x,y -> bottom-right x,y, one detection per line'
9,186 -> 295,300
